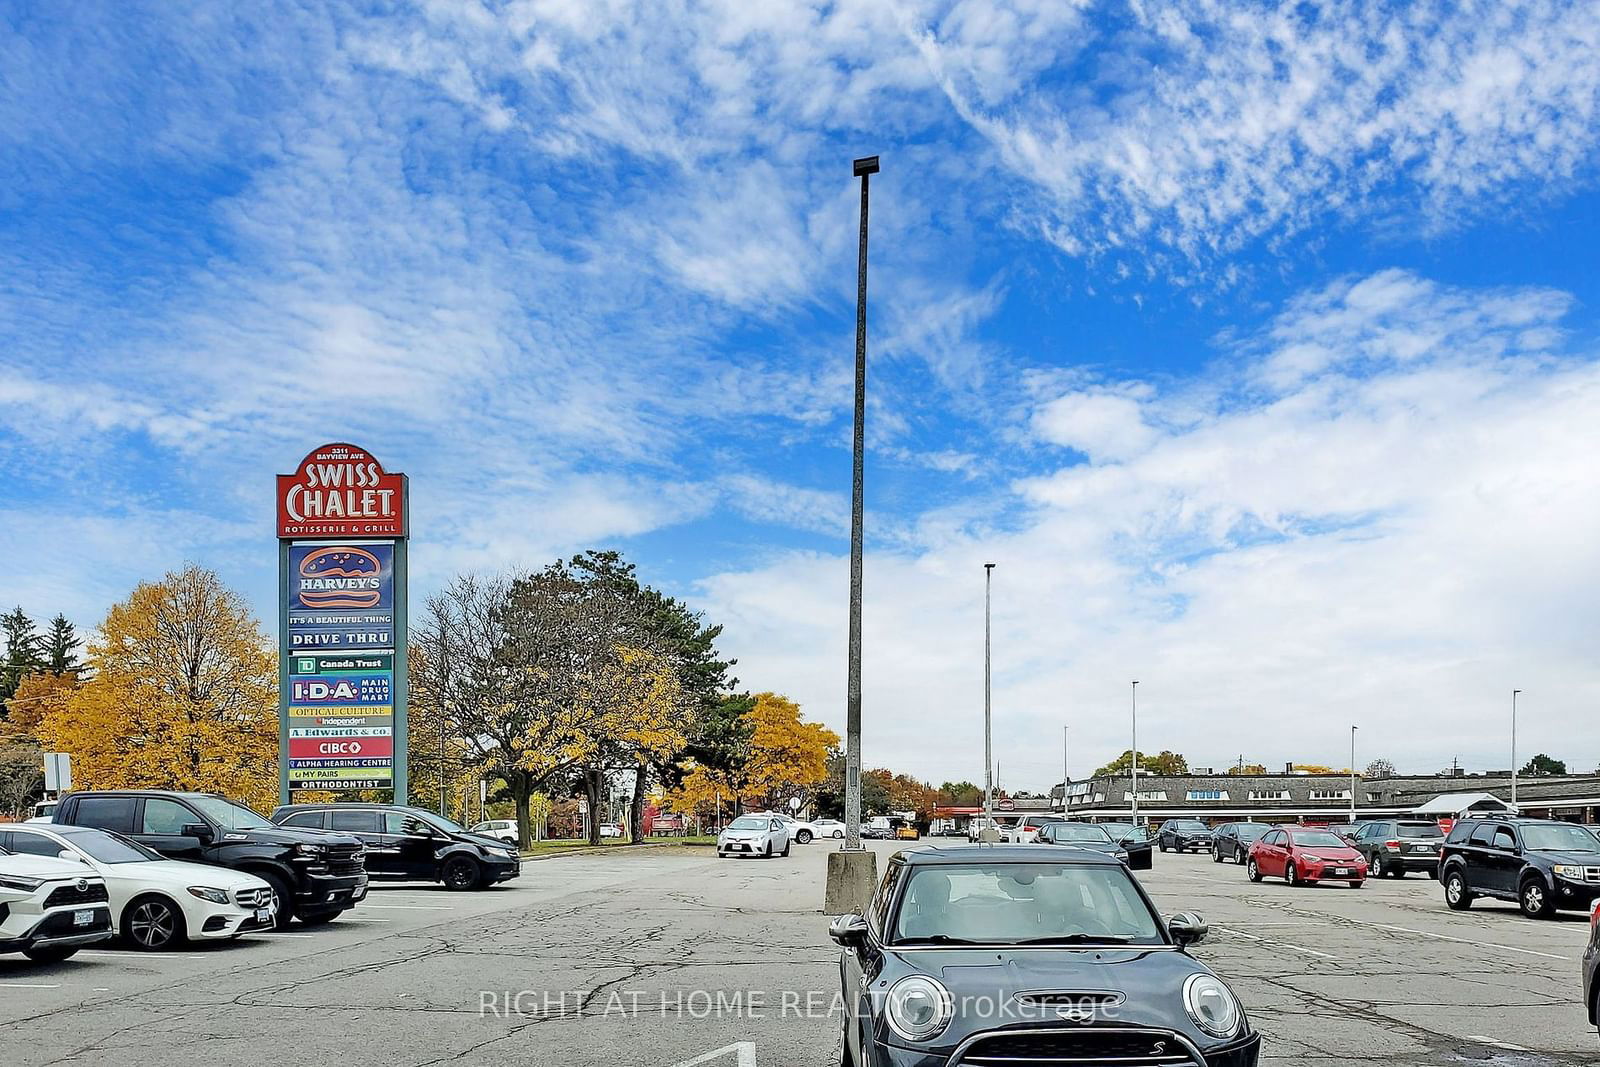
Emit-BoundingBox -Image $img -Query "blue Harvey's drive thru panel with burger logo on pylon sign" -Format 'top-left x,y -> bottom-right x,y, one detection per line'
288,541 -> 395,653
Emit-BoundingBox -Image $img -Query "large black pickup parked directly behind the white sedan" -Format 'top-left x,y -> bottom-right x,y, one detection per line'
54,789 -> 366,929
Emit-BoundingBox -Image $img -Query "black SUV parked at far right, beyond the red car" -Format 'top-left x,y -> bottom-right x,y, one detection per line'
1438,817 -> 1600,918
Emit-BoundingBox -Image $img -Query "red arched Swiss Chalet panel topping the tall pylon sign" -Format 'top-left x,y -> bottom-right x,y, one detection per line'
278,445 -> 406,539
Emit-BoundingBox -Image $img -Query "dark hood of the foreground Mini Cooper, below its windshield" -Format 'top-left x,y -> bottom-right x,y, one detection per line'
874,947 -> 1246,1056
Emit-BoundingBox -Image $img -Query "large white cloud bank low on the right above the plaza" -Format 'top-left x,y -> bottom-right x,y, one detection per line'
704,272 -> 1600,787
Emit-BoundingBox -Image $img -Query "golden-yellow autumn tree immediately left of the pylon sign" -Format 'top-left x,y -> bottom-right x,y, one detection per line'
38,565 -> 278,808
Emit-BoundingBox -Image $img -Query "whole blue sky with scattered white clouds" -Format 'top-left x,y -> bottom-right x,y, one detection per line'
0,0 -> 1600,787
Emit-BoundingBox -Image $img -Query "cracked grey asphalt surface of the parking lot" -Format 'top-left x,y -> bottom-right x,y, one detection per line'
0,841 -> 1600,1067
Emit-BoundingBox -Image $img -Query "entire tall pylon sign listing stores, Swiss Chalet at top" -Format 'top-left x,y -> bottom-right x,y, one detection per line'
277,443 -> 410,805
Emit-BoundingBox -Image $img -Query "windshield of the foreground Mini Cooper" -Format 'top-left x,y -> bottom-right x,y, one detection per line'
893,862 -> 1166,945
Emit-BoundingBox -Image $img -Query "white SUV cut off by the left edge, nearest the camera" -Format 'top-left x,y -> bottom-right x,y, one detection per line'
0,849 -> 112,963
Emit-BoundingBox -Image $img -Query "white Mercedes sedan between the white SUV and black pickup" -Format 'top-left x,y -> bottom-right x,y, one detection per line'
0,822 -> 277,952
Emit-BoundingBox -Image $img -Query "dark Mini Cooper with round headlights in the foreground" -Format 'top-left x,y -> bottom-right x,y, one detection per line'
829,845 -> 1261,1067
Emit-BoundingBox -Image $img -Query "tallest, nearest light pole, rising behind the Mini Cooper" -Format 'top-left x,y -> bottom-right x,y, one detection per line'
845,155 -> 878,849
